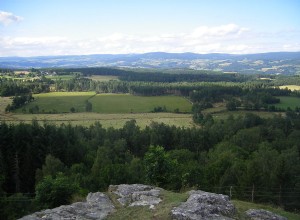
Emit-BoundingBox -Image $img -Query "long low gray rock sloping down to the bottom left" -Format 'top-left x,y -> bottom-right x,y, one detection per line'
21,192 -> 115,220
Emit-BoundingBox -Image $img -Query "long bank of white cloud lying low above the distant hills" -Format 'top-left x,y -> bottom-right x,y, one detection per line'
0,24 -> 300,56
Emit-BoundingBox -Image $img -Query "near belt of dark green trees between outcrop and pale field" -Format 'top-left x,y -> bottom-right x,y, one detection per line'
0,113 -> 300,217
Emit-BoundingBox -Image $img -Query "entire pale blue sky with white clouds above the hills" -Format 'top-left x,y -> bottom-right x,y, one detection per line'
0,0 -> 300,57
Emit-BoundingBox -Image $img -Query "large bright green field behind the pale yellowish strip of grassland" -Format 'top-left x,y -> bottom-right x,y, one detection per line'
15,92 -> 192,114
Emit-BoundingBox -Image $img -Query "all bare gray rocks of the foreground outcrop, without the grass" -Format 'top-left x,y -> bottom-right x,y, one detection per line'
21,184 -> 286,220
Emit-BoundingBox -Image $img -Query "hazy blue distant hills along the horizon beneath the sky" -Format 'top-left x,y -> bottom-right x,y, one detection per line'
0,52 -> 300,74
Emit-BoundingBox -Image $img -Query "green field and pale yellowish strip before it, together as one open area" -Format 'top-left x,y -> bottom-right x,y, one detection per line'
0,92 -> 195,128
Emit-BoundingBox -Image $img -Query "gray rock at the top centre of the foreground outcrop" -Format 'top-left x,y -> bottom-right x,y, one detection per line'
109,184 -> 162,209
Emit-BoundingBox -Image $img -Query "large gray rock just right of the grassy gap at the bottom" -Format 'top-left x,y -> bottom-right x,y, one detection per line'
171,190 -> 235,220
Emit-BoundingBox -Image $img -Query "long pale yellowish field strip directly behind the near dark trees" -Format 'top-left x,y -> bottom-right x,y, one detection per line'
0,112 -> 196,128
